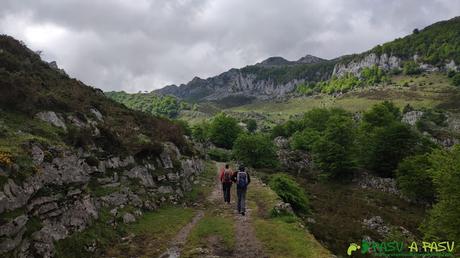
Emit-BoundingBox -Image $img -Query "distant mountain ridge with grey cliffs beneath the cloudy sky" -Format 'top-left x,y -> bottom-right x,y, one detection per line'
156,17 -> 460,102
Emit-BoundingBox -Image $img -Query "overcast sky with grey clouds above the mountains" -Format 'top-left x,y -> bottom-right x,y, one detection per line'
0,0 -> 460,92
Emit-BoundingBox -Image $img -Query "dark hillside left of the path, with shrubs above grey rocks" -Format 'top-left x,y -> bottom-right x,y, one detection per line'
0,35 -> 203,257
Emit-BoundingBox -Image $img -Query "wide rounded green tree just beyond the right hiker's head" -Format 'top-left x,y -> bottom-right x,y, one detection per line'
233,133 -> 277,168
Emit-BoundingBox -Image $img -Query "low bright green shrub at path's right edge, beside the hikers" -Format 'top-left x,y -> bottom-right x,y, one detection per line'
269,174 -> 309,213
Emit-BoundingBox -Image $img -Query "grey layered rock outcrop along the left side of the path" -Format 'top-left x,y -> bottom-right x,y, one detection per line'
0,142 -> 204,257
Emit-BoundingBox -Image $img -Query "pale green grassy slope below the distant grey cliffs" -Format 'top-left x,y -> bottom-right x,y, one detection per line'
229,73 -> 459,120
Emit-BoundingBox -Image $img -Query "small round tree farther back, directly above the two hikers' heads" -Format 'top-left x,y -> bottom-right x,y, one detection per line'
209,113 -> 242,149
